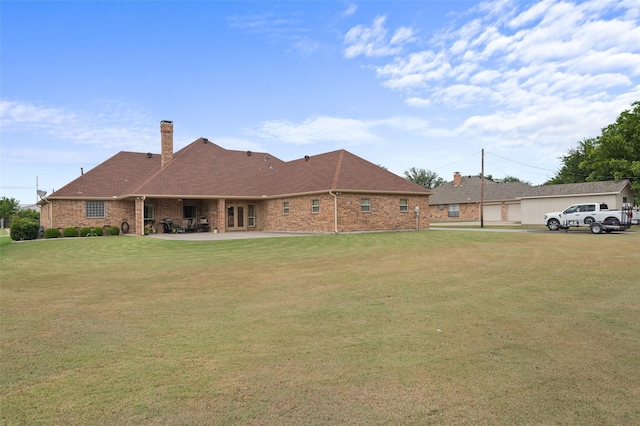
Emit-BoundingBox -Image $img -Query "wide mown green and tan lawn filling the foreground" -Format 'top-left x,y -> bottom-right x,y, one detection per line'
0,231 -> 640,425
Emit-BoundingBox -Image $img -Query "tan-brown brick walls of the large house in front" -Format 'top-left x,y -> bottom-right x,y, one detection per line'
46,193 -> 430,235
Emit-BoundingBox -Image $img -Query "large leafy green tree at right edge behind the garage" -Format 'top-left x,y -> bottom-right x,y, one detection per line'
547,101 -> 640,205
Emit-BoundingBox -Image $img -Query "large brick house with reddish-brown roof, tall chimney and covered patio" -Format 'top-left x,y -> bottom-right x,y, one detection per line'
39,121 -> 432,235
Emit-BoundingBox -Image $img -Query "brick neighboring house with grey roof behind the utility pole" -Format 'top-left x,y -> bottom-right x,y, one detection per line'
429,172 -> 532,222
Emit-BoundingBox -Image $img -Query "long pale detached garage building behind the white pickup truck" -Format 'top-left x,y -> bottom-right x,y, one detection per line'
520,179 -> 633,225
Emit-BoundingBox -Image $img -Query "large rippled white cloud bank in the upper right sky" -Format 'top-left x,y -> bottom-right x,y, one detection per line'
344,0 -> 640,115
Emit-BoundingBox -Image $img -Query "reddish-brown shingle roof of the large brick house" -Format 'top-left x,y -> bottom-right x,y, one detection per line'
50,139 -> 431,199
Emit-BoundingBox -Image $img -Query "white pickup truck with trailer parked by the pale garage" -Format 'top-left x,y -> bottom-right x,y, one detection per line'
544,203 -> 640,231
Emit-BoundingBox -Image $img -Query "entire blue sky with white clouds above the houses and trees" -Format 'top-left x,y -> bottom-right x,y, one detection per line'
0,0 -> 640,203
